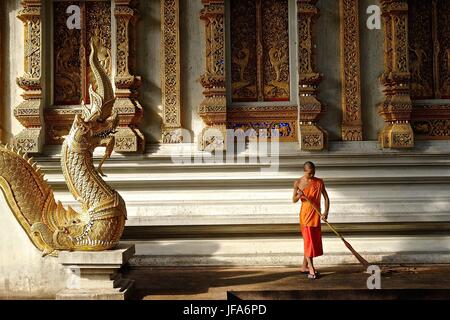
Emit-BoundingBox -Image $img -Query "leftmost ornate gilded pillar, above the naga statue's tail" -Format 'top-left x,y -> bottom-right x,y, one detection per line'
14,0 -> 44,153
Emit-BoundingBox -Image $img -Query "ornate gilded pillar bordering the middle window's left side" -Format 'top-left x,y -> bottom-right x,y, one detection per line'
199,0 -> 227,151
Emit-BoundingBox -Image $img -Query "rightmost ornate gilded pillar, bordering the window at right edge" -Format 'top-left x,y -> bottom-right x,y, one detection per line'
378,0 -> 414,148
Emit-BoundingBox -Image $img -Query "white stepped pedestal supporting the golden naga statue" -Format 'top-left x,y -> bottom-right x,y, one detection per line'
56,245 -> 135,300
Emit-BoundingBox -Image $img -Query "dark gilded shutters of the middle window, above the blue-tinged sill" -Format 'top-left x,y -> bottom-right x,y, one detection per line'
230,0 -> 290,102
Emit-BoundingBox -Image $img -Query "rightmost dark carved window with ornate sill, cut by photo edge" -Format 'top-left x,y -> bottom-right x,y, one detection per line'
408,0 -> 450,140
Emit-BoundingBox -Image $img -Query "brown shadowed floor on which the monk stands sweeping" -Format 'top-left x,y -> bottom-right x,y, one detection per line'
126,265 -> 450,300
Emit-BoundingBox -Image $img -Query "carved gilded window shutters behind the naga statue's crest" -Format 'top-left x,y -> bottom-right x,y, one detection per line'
53,1 -> 112,105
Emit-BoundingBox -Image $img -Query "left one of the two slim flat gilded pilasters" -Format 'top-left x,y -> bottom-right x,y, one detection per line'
161,0 -> 183,143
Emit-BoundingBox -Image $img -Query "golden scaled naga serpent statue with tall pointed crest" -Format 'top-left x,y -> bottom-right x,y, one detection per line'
0,43 -> 127,256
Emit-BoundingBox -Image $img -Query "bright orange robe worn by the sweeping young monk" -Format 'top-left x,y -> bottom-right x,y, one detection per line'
300,178 -> 324,258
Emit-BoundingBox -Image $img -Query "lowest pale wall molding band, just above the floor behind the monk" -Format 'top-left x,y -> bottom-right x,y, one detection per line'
125,234 -> 450,267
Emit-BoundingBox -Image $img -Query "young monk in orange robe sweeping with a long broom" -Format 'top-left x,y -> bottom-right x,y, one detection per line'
292,161 -> 330,279
